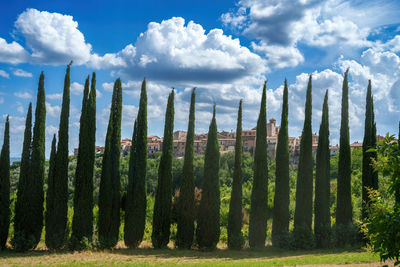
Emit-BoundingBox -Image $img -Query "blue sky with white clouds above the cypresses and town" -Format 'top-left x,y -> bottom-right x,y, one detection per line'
0,0 -> 400,156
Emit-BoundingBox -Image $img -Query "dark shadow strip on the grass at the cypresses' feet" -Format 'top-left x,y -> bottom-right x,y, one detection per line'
0,246 -> 365,260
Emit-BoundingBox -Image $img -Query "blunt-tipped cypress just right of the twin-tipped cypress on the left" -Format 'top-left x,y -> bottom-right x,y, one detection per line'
98,78 -> 122,248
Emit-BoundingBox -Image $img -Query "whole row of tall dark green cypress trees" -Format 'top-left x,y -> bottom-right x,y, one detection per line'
0,65 -> 384,251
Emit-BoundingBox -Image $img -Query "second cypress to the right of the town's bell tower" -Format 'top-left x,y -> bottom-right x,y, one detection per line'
293,75 -> 313,248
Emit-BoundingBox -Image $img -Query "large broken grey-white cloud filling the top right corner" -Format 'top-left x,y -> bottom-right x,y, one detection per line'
221,0 -> 400,68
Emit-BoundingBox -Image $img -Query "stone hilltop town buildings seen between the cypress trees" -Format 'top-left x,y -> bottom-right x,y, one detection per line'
74,118 -> 384,165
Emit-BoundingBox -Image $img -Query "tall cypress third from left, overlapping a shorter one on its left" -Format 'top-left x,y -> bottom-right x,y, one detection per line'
13,72 -> 46,250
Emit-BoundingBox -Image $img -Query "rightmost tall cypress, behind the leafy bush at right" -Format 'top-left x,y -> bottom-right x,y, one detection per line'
362,80 -> 378,219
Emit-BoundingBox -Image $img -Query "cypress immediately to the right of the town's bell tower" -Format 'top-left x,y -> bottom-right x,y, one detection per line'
272,79 -> 290,247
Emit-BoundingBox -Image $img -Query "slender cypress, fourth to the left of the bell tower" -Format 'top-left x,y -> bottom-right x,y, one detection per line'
176,88 -> 196,249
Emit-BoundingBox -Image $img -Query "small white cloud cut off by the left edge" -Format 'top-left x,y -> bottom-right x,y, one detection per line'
0,38 -> 29,64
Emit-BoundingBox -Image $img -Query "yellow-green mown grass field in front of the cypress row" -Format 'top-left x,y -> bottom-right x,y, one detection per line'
0,244 -> 382,266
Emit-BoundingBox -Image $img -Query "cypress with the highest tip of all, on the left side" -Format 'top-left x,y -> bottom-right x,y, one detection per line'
46,65 -> 70,249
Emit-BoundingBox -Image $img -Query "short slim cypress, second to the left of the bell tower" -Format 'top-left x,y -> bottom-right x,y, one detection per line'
228,100 -> 244,249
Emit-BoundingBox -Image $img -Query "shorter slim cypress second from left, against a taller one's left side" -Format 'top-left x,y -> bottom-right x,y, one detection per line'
11,103 -> 32,251
